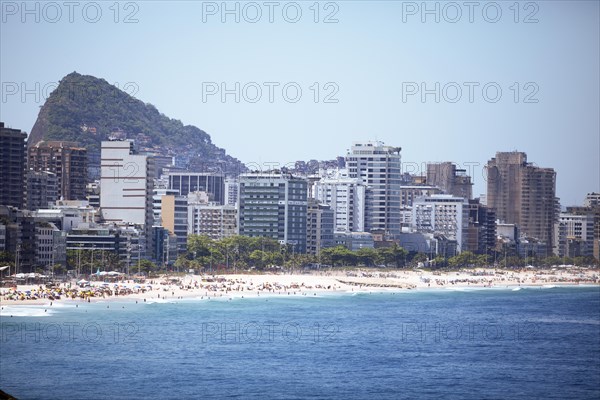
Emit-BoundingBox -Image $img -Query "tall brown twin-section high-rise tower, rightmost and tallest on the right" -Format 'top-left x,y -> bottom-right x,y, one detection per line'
487,152 -> 557,249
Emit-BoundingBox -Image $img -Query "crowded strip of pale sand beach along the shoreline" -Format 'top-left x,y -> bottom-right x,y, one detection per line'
0,268 -> 600,306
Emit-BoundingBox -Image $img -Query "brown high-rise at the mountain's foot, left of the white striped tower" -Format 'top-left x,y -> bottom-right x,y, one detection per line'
27,141 -> 87,200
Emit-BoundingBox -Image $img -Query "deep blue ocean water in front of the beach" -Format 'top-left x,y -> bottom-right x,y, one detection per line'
0,287 -> 600,399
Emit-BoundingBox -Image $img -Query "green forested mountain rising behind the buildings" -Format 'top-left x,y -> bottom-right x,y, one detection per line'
28,72 -> 245,173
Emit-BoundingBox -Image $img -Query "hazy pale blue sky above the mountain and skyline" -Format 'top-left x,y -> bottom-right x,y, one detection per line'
0,0 -> 600,205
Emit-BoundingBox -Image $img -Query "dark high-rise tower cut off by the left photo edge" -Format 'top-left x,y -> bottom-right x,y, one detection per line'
0,122 -> 27,208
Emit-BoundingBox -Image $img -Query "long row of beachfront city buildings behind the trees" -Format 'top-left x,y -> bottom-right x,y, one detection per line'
0,121 -> 600,271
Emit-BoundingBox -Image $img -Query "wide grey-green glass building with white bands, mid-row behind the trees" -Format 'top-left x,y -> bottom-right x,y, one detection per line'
238,172 -> 307,253
